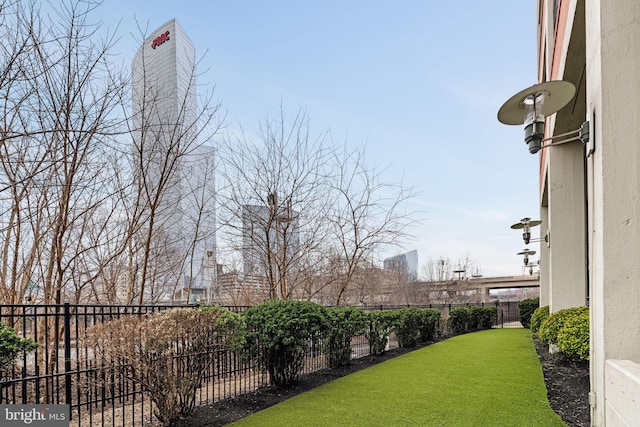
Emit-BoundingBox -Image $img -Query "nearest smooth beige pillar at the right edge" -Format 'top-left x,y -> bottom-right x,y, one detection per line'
586,0 -> 640,426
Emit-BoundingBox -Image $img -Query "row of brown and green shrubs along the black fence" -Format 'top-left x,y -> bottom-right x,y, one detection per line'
81,300 -> 504,423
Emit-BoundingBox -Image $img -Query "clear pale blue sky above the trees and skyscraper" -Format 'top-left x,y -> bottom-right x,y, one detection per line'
86,0 -> 539,276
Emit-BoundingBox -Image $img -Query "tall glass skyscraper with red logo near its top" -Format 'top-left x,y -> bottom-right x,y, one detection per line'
131,19 -> 216,294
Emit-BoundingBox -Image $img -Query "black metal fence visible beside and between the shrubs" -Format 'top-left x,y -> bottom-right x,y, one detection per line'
0,302 -> 522,426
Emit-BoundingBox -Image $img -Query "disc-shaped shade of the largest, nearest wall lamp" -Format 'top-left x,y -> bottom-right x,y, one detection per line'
498,80 -> 576,125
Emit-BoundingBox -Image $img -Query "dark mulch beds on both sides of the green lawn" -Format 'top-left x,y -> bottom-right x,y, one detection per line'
172,342 -> 590,427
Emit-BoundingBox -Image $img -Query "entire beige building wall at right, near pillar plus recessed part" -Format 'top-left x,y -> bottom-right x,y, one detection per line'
539,0 -> 640,426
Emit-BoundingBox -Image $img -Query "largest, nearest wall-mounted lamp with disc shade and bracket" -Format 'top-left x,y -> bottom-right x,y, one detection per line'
498,80 -> 589,154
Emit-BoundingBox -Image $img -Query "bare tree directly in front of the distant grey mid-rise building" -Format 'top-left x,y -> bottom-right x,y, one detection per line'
220,108 -> 332,299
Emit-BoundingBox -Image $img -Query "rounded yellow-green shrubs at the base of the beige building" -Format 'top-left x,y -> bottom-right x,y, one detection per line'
531,306 -> 589,360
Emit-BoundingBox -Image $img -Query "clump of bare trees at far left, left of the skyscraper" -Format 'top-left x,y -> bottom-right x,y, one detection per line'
0,1 -> 126,304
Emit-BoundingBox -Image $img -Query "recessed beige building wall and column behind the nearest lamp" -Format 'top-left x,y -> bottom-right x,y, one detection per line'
539,0 -> 587,312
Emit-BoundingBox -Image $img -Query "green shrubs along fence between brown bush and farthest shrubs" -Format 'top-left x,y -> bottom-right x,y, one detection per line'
239,300 -> 440,386
